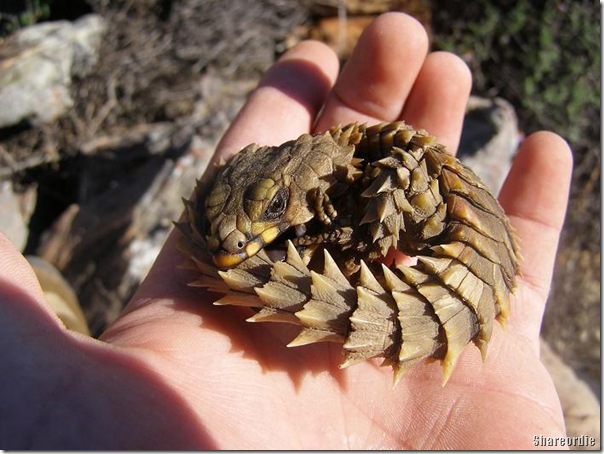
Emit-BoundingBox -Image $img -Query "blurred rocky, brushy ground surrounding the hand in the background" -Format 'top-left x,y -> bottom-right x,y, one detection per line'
0,0 -> 601,446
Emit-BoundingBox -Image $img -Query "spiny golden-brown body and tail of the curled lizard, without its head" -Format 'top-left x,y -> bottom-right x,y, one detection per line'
176,122 -> 520,383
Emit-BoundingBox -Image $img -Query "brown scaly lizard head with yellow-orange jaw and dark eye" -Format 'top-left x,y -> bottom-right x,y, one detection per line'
204,144 -> 312,269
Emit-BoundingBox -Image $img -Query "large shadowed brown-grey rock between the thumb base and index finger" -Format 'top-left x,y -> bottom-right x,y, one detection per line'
31,62 -> 250,335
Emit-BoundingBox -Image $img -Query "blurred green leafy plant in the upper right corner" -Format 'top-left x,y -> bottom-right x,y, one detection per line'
435,0 -> 601,147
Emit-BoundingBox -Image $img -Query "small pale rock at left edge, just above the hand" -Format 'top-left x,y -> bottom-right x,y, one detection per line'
0,181 -> 36,251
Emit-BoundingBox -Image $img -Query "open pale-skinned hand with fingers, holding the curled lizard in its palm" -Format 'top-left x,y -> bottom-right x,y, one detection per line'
0,13 -> 572,449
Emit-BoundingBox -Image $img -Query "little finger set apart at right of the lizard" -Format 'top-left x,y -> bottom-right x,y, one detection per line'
499,132 -> 572,302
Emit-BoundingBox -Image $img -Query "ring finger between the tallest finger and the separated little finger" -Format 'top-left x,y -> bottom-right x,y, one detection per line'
401,52 -> 472,153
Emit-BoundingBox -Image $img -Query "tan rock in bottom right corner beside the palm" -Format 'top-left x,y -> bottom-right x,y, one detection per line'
541,340 -> 600,450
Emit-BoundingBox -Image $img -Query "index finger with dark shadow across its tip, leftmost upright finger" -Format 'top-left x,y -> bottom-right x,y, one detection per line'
215,41 -> 339,163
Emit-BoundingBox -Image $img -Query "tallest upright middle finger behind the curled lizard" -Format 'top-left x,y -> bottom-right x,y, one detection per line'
315,13 -> 428,131
